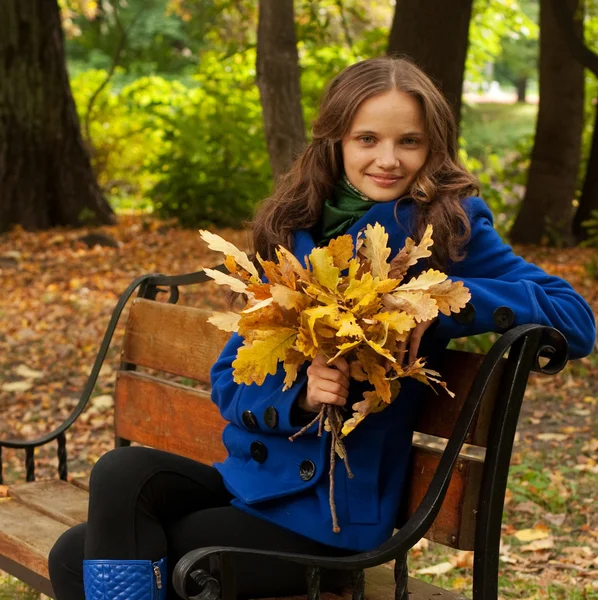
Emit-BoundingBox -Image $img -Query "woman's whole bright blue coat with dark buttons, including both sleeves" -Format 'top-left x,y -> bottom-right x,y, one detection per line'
211,197 -> 596,551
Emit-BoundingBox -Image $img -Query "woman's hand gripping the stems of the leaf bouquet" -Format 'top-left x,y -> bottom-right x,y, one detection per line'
297,354 -> 350,413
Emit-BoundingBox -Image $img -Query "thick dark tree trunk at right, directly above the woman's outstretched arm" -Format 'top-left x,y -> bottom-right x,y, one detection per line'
511,0 -> 584,244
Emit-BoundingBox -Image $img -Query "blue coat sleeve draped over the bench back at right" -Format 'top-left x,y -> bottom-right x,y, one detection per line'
435,198 -> 596,358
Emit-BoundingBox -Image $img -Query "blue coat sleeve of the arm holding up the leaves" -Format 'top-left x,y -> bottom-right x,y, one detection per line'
210,333 -> 315,435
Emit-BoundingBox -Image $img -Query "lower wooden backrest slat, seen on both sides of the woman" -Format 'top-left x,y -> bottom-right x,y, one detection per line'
115,371 -> 483,550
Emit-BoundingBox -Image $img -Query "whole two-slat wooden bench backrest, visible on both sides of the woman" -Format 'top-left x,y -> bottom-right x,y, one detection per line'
115,299 -> 500,550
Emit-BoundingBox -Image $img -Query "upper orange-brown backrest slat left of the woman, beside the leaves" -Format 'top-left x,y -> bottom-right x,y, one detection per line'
122,299 -> 230,383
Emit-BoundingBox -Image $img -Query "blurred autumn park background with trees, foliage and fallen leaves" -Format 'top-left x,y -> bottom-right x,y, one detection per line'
0,0 -> 598,600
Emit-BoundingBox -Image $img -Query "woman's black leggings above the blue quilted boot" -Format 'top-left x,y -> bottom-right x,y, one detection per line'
49,447 -> 354,600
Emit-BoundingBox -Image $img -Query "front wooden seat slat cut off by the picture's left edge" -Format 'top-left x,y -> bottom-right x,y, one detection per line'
0,498 -> 69,579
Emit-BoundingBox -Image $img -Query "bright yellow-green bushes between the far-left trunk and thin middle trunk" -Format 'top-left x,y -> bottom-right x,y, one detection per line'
72,51 -> 271,226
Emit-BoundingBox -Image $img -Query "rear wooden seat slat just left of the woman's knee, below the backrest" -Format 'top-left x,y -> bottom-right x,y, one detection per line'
8,479 -> 89,527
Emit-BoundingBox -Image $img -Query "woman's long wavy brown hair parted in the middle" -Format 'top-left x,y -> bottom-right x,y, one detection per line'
252,57 -> 477,269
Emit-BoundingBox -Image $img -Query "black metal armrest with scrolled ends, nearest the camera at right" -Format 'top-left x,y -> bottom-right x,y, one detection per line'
173,325 -> 568,600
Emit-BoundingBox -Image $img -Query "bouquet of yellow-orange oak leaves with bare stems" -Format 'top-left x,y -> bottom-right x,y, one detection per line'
200,223 -> 470,530
